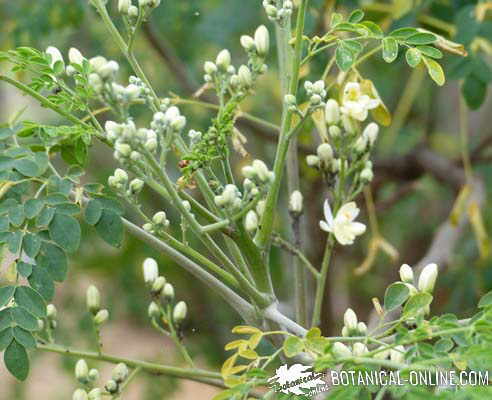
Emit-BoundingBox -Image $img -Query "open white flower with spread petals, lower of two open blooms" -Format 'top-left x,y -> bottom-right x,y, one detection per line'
319,200 -> 366,246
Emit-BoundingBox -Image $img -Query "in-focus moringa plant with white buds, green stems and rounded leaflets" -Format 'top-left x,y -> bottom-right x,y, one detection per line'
0,0 -> 492,400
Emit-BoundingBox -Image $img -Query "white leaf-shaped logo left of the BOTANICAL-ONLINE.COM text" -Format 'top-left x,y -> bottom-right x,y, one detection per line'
268,364 -> 326,396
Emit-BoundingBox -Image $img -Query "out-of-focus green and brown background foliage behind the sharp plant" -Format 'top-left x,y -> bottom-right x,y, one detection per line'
0,0 -> 492,400
